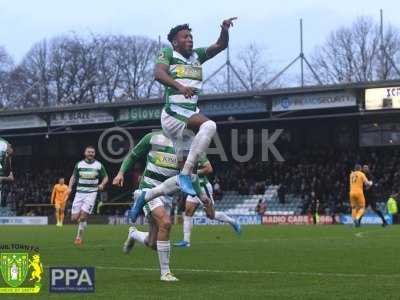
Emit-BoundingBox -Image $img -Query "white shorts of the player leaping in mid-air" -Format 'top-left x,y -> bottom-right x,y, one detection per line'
161,106 -> 198,158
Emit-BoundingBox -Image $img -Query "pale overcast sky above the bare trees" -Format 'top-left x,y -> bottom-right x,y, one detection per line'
0,0 -> 400,77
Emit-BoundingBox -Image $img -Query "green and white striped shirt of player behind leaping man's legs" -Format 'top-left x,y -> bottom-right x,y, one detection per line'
121,131 -> 179,189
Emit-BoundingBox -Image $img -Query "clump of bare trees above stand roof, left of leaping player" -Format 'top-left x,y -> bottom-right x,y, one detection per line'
4,35 -> 159,107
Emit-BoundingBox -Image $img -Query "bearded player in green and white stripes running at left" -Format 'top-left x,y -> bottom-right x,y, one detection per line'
67,146 -> 108,246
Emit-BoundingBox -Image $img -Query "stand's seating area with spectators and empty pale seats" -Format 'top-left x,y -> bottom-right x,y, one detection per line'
2,139 -> 400,215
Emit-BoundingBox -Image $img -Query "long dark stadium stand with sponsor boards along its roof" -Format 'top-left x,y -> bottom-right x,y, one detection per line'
0,81 -> 400,224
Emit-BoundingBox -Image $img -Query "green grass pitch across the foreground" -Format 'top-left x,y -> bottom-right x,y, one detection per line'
0,225 -> 400,300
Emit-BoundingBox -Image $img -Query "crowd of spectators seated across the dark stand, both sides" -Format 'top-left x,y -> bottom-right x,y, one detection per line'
2,147 -> 400,215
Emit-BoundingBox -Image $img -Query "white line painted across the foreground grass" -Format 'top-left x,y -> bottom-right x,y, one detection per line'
96,266 -> 400,278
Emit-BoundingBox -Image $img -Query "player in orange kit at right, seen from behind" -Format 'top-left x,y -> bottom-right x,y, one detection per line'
350,164 -> 372,227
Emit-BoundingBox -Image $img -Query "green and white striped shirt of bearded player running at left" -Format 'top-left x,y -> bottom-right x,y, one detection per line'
74,159 -> 107,193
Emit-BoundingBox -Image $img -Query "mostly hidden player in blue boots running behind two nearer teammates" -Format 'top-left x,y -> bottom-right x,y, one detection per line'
174,153 -> 241,248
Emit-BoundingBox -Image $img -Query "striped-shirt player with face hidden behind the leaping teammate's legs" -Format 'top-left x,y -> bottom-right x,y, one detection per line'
113,131 -> 210,281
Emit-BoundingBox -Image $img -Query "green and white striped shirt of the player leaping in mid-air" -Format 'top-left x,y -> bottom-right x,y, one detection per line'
156,48 -> 208,121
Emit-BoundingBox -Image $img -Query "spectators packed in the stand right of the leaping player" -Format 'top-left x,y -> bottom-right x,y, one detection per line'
214,148 -> 400,214
